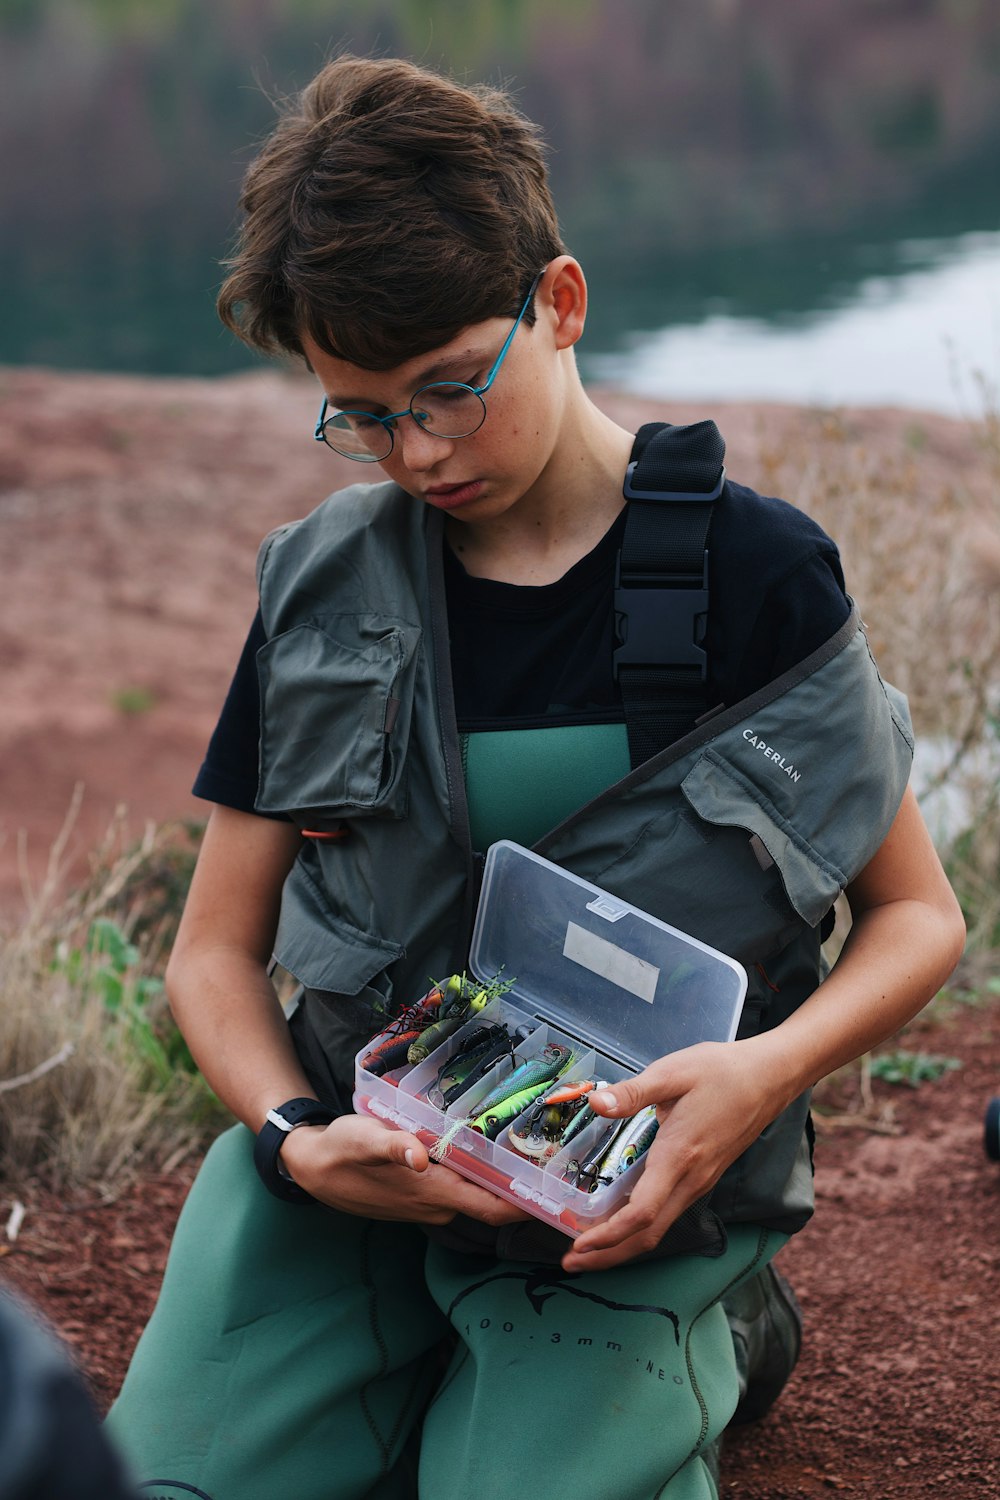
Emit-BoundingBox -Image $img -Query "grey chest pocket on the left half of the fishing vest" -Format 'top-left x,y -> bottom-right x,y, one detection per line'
256,617 -> 420,827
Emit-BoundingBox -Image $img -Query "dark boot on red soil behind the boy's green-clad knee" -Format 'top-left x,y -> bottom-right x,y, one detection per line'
723,1266 -> 802,1427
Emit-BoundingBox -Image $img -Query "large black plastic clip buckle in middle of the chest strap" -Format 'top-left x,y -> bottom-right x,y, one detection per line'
612,552 -> 708,683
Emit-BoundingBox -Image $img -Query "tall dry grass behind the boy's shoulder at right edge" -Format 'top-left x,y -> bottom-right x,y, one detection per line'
759,413 -> 1000,968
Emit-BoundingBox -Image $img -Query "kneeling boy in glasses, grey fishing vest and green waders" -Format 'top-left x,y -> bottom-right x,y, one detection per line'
105,57 -> 963,1500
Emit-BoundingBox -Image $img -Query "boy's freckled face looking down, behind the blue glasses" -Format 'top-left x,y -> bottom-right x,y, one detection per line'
301,277 -> 575,522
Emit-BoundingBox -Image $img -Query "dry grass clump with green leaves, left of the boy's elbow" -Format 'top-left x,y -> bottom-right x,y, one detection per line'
0,810 -> 225,1188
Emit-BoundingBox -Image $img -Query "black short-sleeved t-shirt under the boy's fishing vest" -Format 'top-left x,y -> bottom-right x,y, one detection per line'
193,482 -> 850,812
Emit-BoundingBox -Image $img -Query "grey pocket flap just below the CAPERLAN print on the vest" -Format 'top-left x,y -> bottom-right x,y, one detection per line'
681,750 -> 847,927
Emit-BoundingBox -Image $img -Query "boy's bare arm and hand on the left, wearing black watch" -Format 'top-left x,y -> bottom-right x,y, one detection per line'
166,807 -> 525,1224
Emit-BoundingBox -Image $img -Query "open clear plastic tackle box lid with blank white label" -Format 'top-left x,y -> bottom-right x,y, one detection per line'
469,839 -> 747,1068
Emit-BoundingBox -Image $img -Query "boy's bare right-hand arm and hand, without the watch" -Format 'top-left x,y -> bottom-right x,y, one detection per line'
562,791 -> 966,1271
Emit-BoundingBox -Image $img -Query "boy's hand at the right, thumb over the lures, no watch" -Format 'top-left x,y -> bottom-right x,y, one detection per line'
562,1034 -> 795,1271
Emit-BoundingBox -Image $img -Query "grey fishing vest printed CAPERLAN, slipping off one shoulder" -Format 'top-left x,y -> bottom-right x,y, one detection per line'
256,483 -> 913,1250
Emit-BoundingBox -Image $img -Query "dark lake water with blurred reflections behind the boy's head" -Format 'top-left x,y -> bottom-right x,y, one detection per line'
0,0 -> 1000,414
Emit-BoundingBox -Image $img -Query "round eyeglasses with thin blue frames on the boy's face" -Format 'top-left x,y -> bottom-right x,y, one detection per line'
313,270 -> 544,464
